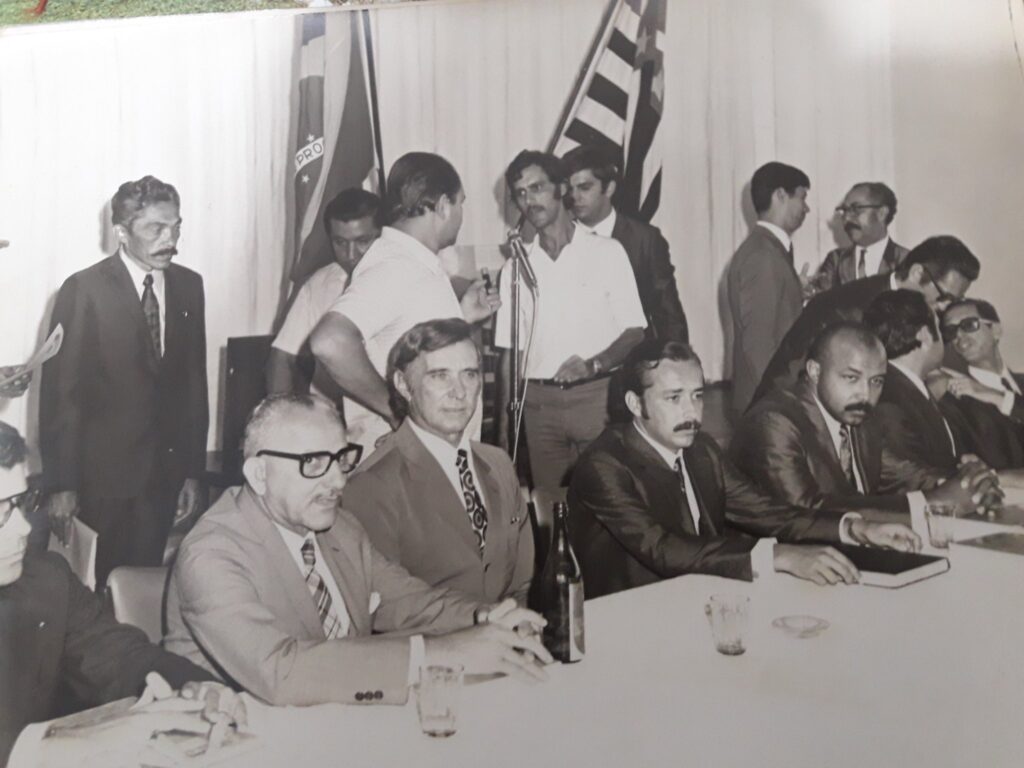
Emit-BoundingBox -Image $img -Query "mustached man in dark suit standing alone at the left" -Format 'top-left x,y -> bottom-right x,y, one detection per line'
40,176 -> 209,589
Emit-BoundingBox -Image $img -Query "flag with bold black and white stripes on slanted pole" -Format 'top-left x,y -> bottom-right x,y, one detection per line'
553,0 -> 667,221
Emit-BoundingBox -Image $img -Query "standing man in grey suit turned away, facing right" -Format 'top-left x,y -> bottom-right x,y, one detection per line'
726,163 -> 811,414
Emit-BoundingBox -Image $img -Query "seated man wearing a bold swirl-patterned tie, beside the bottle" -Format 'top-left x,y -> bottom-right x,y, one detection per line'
345,317 -> 534,604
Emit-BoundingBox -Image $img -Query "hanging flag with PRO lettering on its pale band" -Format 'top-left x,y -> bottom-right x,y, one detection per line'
286,11 -> 382,284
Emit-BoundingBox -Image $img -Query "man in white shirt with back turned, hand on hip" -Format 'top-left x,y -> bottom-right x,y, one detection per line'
309,152 -> 499,447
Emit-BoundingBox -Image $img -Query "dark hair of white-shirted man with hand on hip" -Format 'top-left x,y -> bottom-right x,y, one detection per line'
384,152 -> 462,224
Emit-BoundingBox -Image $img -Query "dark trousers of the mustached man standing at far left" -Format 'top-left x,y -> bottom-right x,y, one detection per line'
79,471 -> 182,592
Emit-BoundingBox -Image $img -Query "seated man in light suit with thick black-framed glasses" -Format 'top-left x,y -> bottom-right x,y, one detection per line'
164,394 -> 551,705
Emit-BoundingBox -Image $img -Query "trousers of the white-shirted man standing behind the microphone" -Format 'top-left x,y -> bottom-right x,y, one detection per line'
523,378 -> 609,488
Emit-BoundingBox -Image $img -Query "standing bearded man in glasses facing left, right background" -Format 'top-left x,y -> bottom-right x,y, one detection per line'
813,181 -> 908,291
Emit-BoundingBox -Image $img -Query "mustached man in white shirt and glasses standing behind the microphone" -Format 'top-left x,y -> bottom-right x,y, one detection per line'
495,151 -> 647,488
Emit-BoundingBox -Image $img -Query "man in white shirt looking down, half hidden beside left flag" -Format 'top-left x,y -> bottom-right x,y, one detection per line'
266,187 -> 381,394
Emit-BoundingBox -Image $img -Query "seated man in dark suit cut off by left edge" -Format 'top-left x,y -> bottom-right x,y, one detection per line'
0,422 -> 241,766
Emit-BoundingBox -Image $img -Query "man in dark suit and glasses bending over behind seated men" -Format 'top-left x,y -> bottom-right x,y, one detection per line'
754,234 -> 981,402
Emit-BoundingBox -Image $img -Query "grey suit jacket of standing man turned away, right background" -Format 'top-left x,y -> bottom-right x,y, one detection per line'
726,225 -> 804,413
